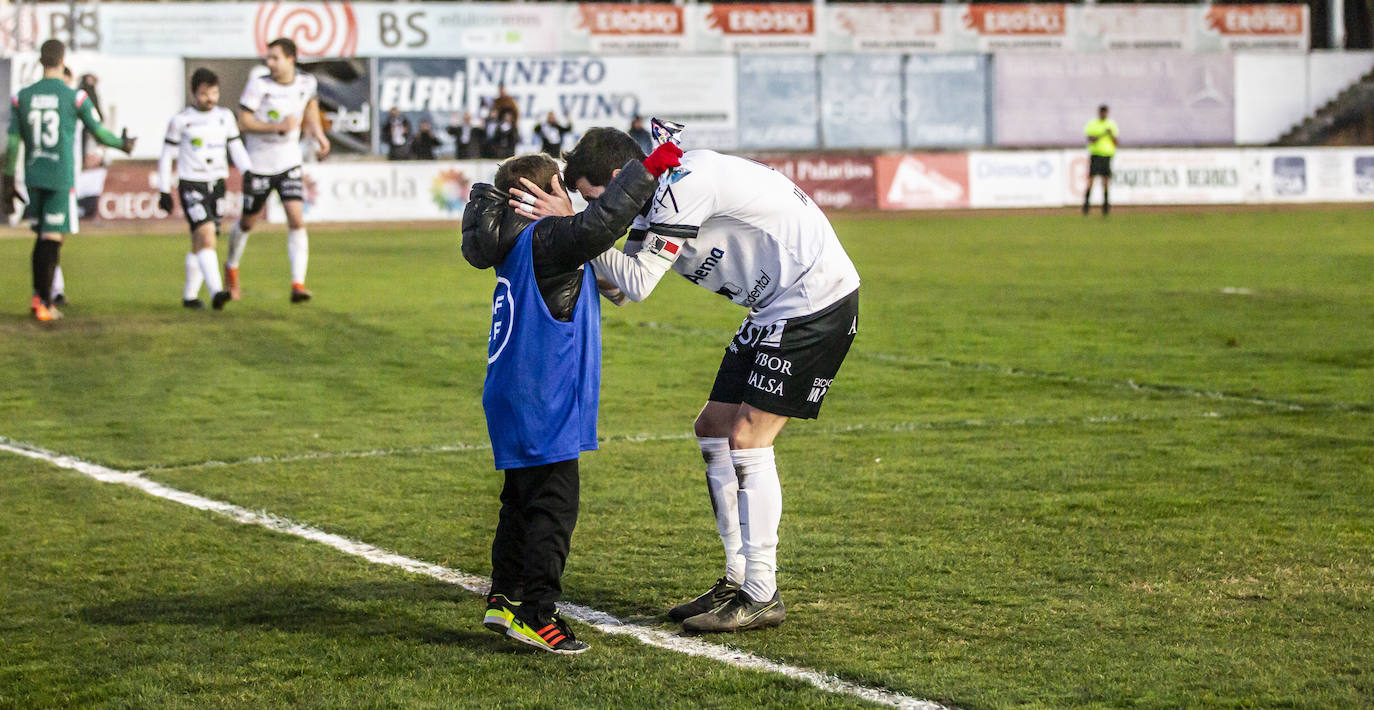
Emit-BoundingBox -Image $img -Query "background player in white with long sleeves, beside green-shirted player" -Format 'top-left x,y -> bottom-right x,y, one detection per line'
158,67 -> 253,310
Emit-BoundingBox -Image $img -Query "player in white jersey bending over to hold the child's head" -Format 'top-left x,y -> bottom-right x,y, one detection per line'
524,121 -> 859,633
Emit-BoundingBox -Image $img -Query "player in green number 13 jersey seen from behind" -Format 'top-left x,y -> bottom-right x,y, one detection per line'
3,40 -> 135,321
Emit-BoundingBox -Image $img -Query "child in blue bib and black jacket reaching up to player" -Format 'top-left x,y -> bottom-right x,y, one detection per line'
463,140 -> 682,654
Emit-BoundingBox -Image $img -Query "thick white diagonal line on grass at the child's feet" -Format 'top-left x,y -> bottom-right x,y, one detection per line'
0,439 -> 945,710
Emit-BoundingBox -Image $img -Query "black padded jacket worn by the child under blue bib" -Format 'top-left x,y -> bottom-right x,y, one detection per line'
463,161 -> 658,321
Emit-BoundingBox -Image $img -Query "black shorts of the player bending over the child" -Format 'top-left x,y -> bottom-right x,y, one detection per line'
710,291 -> 859,419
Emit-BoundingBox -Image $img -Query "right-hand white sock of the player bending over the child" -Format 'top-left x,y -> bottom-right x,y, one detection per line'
730,446 -> 782,602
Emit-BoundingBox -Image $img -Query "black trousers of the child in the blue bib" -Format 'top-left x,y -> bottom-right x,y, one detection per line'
492,459 -> 578,619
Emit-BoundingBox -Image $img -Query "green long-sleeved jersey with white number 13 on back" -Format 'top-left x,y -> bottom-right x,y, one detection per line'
5,78 -> 124,192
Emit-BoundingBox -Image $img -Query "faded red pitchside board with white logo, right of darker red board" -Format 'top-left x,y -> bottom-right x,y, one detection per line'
874,152 -> 969,210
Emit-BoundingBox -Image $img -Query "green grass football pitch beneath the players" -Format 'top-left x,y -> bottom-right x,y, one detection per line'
0,210 -> 1374,709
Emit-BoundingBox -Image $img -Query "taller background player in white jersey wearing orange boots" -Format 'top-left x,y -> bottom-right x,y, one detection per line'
224,37 -> 330,304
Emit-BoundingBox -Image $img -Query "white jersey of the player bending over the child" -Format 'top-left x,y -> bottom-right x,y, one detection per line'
635,150 -> 859,324
